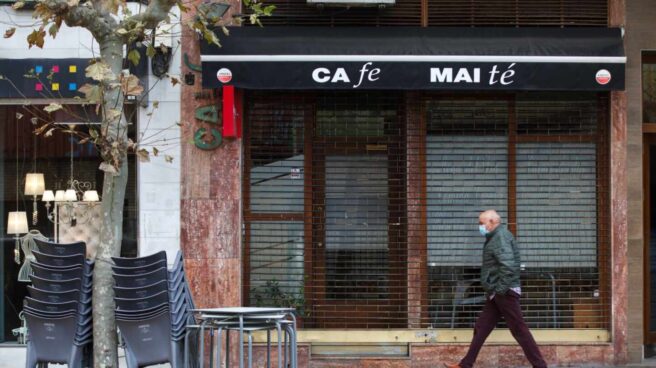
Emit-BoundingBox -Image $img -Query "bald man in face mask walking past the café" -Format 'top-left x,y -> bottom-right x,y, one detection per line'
444,210 -> 547,368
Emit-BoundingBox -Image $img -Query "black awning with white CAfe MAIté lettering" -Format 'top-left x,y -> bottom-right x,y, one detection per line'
201,27 -> 626,91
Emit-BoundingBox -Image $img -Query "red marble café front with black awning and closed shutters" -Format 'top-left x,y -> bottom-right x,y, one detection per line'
181,0 -> 636,367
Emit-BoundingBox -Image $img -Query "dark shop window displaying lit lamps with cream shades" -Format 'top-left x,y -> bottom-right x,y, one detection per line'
0,105 -> 138,341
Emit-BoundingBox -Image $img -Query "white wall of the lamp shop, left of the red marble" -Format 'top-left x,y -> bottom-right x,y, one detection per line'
0,3 -> 181,259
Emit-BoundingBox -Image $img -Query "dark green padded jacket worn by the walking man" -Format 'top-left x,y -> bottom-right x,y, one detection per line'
481,225 -> 520,295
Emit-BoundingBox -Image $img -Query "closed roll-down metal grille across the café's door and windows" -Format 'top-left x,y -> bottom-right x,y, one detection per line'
243,91 -> 610,328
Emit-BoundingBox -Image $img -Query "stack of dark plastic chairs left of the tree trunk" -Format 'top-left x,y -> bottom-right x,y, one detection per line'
23,239 -> 93,368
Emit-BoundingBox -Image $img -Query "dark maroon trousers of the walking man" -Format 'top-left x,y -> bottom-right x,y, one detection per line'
460,290 -> 547,368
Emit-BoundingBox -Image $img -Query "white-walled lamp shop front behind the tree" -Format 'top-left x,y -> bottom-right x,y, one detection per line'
0,3 -> 181,344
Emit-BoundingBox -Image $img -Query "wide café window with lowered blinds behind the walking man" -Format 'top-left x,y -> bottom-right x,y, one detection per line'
426,93 -> 609,328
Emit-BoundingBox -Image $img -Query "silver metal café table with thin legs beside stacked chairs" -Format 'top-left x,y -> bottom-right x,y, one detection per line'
185,307 -> 297,368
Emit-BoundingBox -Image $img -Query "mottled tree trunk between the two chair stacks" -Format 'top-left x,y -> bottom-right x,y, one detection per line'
93,36 -> 128,368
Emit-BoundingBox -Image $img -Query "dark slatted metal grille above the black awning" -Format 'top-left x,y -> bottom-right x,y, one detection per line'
249,0 -> 608,27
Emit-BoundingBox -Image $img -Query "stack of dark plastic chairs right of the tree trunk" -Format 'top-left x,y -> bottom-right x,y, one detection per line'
112,251 -> 195,368
